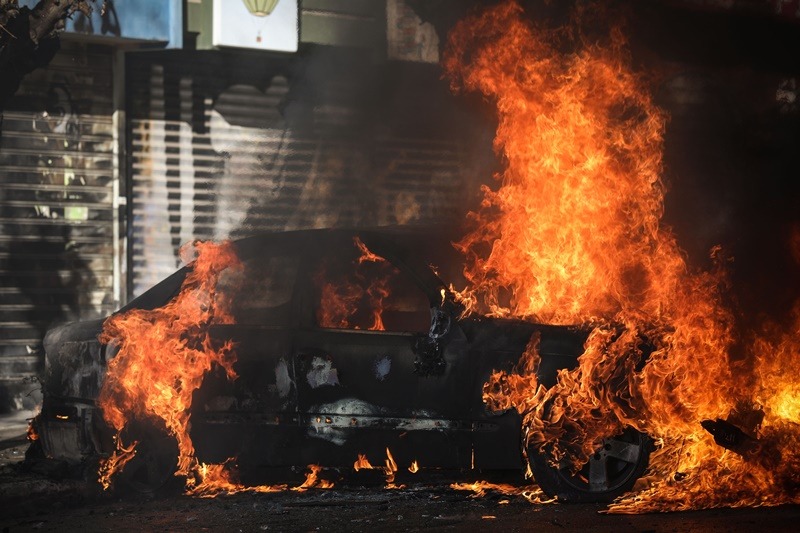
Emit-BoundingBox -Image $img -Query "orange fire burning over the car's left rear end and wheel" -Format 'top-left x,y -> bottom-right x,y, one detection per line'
98,243 -> 239,488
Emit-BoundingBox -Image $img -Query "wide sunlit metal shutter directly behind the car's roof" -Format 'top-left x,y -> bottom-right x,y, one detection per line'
126,49 -> 477,295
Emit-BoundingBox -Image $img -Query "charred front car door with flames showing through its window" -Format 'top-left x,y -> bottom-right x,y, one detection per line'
294,239 -> 470,468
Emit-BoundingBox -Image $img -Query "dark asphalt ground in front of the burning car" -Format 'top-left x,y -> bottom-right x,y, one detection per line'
0,414 -> 800,533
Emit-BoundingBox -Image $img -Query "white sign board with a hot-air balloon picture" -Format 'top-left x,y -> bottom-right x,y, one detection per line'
212,0 -> 298,52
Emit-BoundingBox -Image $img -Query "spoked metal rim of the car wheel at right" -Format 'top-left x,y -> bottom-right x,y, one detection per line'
558,428 -> 646,493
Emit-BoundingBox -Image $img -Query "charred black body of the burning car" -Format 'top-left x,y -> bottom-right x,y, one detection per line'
35,230 -> 649,501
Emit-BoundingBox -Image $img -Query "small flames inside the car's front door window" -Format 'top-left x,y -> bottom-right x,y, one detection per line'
315,237 -> 394,331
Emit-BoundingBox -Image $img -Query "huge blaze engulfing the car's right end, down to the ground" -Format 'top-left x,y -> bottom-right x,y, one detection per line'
443,1 -> 800,512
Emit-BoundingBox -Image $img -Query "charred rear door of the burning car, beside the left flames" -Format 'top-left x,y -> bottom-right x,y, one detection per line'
192,243 -> 302,466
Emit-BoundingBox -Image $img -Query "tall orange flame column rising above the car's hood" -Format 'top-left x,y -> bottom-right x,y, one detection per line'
444,2 -> 685,324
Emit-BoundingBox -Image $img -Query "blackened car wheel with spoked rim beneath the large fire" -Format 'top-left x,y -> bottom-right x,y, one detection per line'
528,428 -> 653,503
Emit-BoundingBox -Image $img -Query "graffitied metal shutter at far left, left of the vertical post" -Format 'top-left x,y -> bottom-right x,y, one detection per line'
0,42 -> 115,406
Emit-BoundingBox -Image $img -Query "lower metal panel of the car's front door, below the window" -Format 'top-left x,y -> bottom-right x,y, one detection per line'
295,329 -> 471,468
